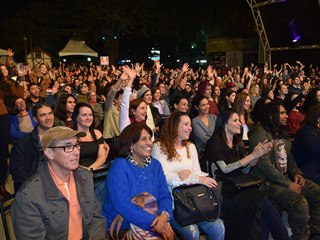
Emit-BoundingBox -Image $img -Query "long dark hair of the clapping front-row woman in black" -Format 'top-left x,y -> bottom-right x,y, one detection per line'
212,109 -> 245,156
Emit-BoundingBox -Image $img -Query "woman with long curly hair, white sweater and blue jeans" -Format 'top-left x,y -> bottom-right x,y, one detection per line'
152,111 -> 224,240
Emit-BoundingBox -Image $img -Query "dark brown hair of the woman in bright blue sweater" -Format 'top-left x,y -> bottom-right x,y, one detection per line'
116,122 -> 152,158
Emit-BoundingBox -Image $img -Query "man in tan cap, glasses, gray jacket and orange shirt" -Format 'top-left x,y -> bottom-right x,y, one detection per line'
11,126 -> 106,240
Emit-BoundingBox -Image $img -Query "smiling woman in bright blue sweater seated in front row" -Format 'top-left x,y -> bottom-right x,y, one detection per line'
103,123 -> 174,240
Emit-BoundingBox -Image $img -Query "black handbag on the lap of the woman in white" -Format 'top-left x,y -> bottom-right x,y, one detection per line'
172,182 -> 222,226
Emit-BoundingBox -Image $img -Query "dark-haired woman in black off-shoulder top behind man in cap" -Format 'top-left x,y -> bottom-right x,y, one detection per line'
72,102 -> 109,170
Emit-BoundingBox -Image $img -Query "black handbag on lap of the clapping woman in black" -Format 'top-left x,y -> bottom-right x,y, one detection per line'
216,174 -> 264,194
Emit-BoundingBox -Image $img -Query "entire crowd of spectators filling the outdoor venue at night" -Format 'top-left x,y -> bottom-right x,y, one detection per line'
0,49 -> 320,240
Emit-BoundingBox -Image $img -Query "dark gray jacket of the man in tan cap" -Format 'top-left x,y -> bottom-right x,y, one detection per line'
11,163 -> 106,240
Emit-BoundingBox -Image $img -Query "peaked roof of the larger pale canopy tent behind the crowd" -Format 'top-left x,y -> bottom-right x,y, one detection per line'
59,40 -> 98,57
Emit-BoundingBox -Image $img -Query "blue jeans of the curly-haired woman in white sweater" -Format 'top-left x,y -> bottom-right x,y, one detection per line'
170,218 -> 225,240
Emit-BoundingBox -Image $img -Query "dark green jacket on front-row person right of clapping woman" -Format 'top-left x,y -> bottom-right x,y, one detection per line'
249,125 -> 303,187
